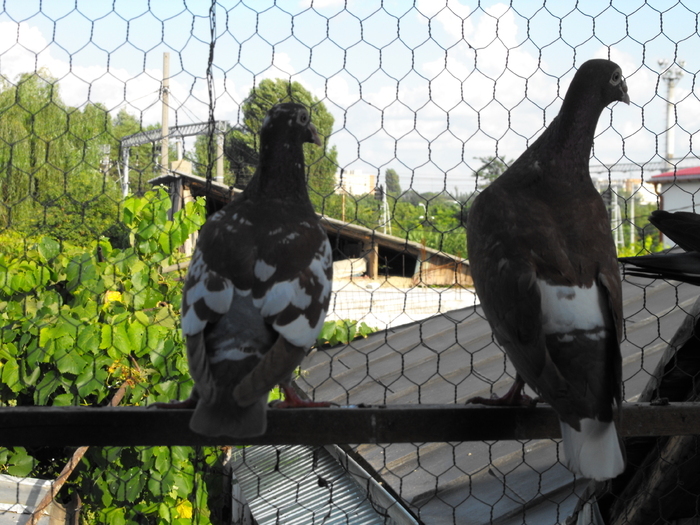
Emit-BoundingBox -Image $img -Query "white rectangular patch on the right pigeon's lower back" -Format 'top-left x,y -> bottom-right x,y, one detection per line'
537,279 -> 605,342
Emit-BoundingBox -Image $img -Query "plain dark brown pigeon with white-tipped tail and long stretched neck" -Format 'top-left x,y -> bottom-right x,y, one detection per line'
467,60 -> 629,480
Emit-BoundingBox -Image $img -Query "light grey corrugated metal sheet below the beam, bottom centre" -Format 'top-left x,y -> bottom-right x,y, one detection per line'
232,446 -> 416,525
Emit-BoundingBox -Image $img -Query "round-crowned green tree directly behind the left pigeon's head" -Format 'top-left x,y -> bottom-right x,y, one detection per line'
226,78 -> 338,210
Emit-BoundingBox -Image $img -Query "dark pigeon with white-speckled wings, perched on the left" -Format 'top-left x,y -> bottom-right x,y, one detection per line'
163,103 -> 333,438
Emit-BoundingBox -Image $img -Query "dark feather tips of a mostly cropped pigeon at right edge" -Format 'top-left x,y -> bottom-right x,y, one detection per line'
619,210 -> 700,286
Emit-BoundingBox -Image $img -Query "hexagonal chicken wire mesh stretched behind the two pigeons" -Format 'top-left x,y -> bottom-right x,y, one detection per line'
0,0 -> 700,523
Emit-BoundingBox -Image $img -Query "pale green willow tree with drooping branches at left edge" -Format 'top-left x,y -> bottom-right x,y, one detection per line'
0,69 -> 118,243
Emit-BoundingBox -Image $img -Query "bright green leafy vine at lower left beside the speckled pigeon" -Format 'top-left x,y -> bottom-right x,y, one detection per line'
0,189 -> 227,525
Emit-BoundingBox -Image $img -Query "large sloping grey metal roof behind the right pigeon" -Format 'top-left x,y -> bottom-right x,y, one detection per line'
299,277 -> 698,524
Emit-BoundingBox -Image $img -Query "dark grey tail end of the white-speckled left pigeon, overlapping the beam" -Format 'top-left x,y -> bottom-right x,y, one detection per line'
190,396 -> 267,439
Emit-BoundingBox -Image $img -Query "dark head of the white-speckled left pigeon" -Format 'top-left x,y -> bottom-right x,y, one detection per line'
260,102 -> 321,149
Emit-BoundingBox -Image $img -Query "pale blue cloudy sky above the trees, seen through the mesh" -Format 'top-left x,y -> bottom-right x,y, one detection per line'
0,0 -> 700,194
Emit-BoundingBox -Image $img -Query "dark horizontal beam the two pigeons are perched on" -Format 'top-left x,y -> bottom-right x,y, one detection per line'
0,403 -> 700,446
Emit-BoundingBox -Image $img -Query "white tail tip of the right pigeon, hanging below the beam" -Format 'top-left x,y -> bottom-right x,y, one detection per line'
560,418 -> 625,481
